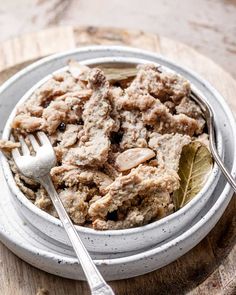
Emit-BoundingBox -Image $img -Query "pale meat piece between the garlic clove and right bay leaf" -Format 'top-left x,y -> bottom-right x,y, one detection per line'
148,132 -> 191,172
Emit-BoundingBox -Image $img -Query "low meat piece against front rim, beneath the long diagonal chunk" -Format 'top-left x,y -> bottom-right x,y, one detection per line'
93,192 -> 171,230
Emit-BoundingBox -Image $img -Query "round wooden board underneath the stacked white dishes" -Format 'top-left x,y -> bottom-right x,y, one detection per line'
0,27 -> 236,295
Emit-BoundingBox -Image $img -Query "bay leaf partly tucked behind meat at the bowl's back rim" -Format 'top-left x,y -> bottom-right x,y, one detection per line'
100,66 -> 138,82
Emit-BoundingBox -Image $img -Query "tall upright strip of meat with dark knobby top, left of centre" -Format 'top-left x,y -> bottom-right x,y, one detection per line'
65,69 -> 114,166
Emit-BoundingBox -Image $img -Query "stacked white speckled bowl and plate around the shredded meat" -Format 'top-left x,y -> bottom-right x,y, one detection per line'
0,46 -> 236,280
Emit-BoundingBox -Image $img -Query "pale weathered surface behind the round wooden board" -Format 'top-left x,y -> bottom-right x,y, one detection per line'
0,0 -> 236,77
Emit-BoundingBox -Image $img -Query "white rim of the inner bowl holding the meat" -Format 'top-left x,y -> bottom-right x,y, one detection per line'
0,53 -> 223,237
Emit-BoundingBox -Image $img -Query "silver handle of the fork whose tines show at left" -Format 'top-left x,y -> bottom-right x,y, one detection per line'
39,174 -> 114,295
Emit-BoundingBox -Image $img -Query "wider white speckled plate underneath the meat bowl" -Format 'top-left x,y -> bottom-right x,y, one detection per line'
0,47 -> 236,280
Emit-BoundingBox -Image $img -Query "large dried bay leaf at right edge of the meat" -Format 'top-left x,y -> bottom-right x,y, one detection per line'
173,141 -> 213,210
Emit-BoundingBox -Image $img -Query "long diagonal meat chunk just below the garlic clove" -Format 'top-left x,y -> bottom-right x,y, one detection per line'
89,165 -> 179,218
